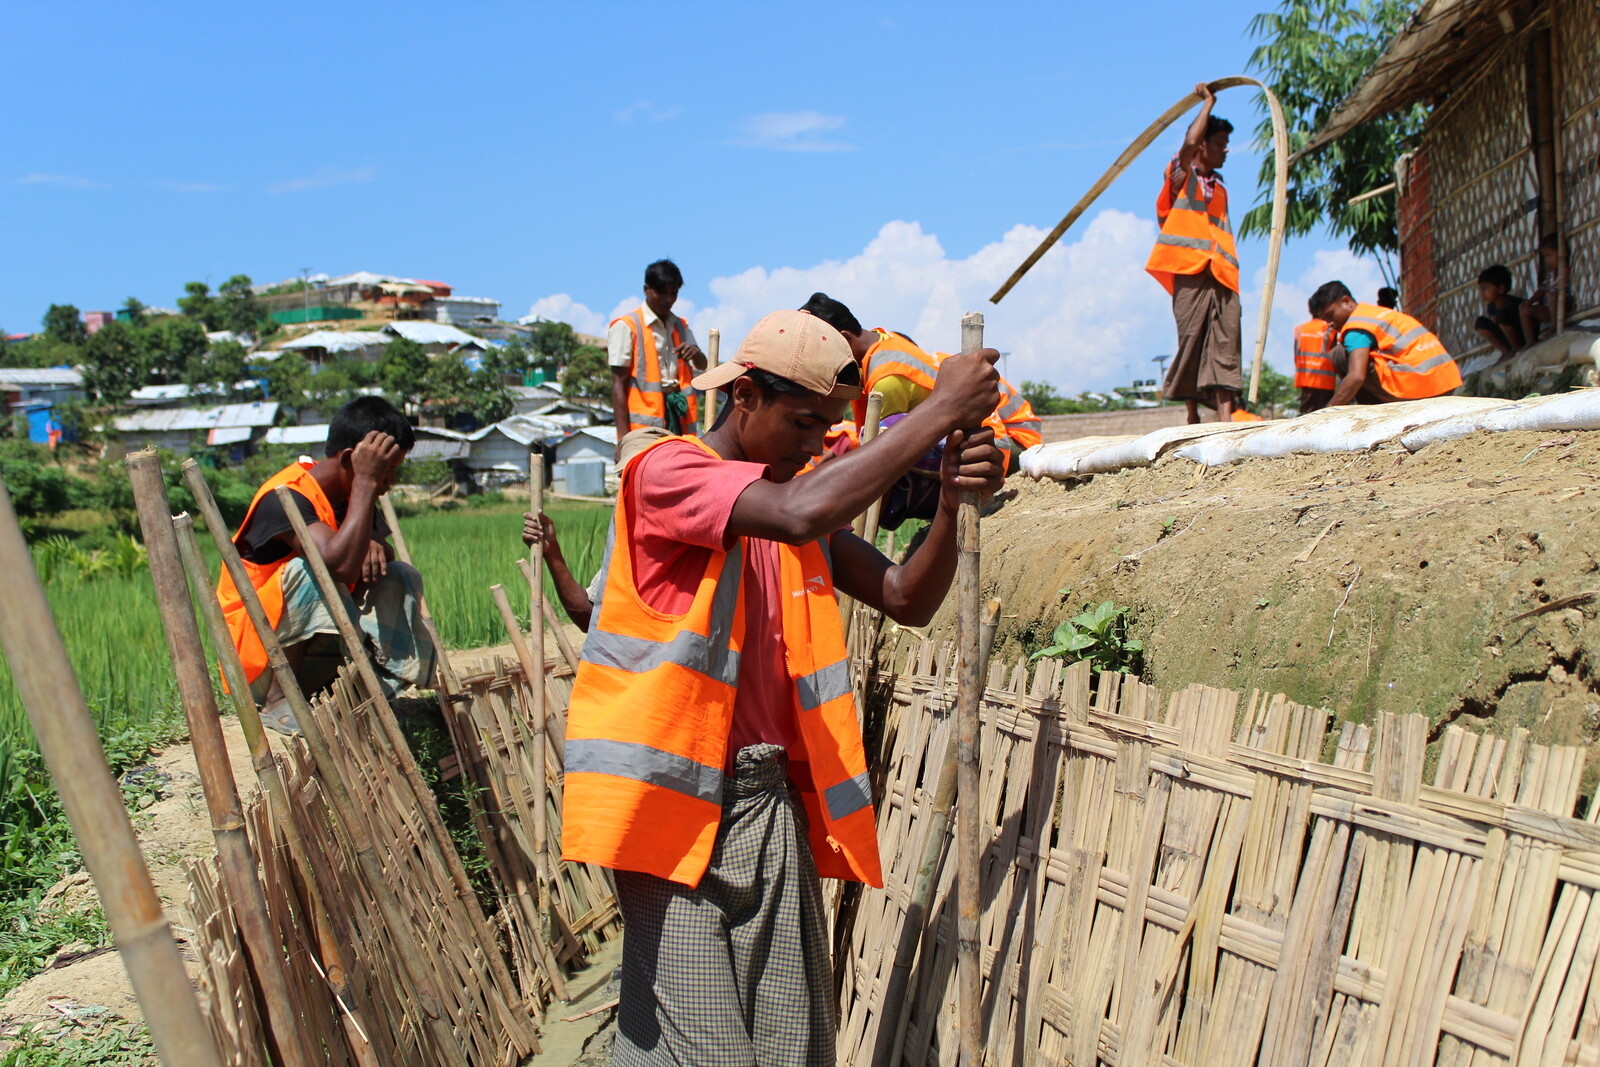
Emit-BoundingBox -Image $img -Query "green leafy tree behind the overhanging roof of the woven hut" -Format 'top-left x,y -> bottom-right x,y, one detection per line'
1238,0 -> 1427,267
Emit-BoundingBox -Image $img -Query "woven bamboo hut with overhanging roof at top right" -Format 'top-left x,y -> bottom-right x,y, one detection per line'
1301,0 -> 1600,388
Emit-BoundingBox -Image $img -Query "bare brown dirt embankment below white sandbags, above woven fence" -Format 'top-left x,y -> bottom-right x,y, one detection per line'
933,430 -> 1600,785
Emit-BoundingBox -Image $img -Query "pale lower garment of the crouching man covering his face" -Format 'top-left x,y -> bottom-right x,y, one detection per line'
251,557 -> 437,701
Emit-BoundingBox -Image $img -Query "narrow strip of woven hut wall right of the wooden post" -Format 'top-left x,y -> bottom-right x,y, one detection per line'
1550,0 -> 1600,321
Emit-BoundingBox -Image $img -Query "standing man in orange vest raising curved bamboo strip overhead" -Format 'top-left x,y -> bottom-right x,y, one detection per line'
1144,82 -> 1243,422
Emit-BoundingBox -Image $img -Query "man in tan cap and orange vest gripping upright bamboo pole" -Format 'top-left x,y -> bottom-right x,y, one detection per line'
562,310 -> 1002,1067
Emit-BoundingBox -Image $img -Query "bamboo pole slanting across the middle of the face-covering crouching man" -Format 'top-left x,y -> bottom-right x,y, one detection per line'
274,485 -> 533,1041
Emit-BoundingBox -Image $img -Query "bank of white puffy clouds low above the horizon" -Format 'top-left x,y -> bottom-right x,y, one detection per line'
530,217 -> 1381,394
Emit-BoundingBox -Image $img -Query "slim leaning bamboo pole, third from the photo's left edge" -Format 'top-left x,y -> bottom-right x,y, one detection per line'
182,459 -> 467,1067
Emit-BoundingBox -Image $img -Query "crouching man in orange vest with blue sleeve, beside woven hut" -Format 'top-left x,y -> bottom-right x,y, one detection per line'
1310,282 -> 1461,408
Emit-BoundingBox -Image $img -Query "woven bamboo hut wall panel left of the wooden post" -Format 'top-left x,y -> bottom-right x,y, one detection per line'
1422,35 -> 1539,358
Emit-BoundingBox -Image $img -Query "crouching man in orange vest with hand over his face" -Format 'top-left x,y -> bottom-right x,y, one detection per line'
216,397 -> 435,733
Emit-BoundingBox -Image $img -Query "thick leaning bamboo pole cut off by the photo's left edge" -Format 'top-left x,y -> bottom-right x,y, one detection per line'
0,482 -> 222,1067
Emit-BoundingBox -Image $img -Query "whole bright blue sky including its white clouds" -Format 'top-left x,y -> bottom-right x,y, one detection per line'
0,0 -> 1378,390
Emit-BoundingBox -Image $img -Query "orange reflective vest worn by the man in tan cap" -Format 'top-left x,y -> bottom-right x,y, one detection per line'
562,437 -> 883,886
